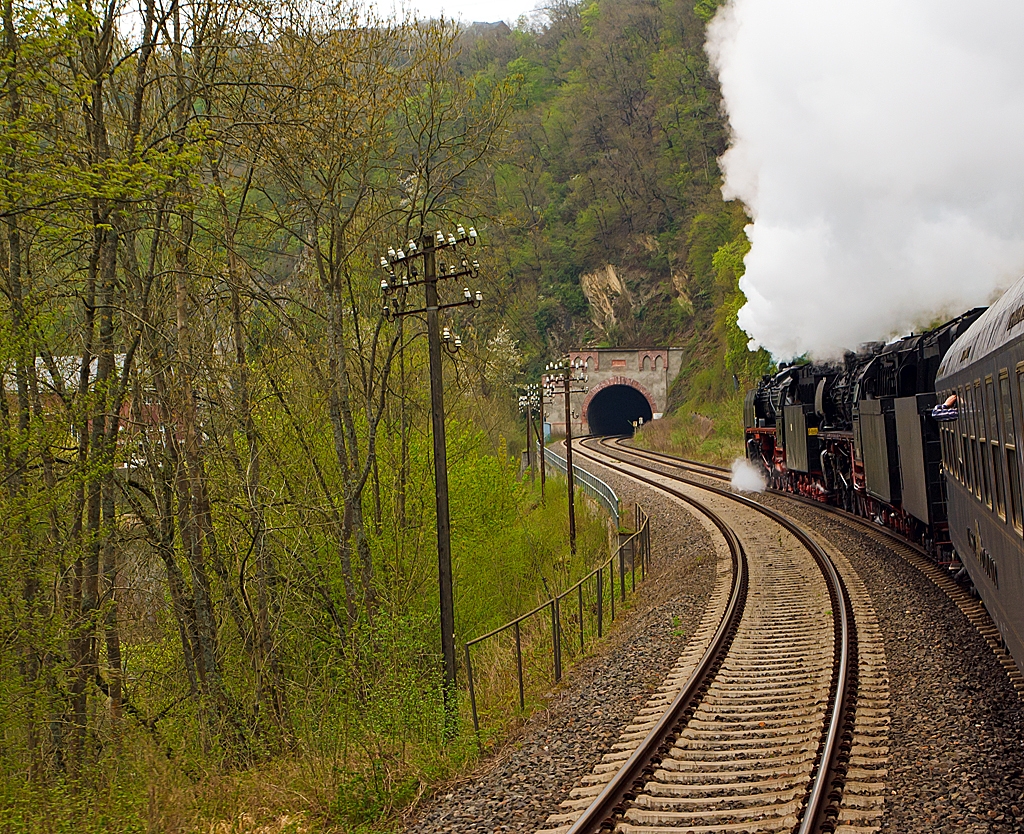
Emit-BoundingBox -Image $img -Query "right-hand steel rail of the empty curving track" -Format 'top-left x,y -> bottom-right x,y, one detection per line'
570,437 -> 857,834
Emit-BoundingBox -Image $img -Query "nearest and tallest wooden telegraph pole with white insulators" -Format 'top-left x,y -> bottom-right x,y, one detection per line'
380,224 -> 483,736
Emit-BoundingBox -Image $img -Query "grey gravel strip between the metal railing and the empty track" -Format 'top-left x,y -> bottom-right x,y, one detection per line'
406,462 -> 715,834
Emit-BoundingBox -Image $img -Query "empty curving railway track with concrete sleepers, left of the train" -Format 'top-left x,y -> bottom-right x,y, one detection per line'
544,445 -> 888,834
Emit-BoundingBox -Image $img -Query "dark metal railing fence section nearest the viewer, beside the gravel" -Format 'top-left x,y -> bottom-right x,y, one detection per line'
465,504 -> 650,734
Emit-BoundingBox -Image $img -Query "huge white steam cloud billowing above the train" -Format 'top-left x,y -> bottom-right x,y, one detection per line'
707,0 -> 1024,359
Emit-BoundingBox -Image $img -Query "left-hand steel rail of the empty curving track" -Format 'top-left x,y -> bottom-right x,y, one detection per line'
568,455 -> 748,834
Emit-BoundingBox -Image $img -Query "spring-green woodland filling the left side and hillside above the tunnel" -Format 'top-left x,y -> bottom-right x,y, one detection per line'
0,0 -> 764,832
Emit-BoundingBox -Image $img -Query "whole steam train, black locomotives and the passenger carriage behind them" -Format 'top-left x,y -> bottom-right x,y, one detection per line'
743,279 -> 1024,668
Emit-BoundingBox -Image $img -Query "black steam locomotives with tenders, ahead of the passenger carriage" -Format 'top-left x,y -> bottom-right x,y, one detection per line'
743,309 -> 983,560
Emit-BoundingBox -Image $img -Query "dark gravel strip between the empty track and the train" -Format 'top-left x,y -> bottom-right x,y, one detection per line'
764,496 -> 1024,834
